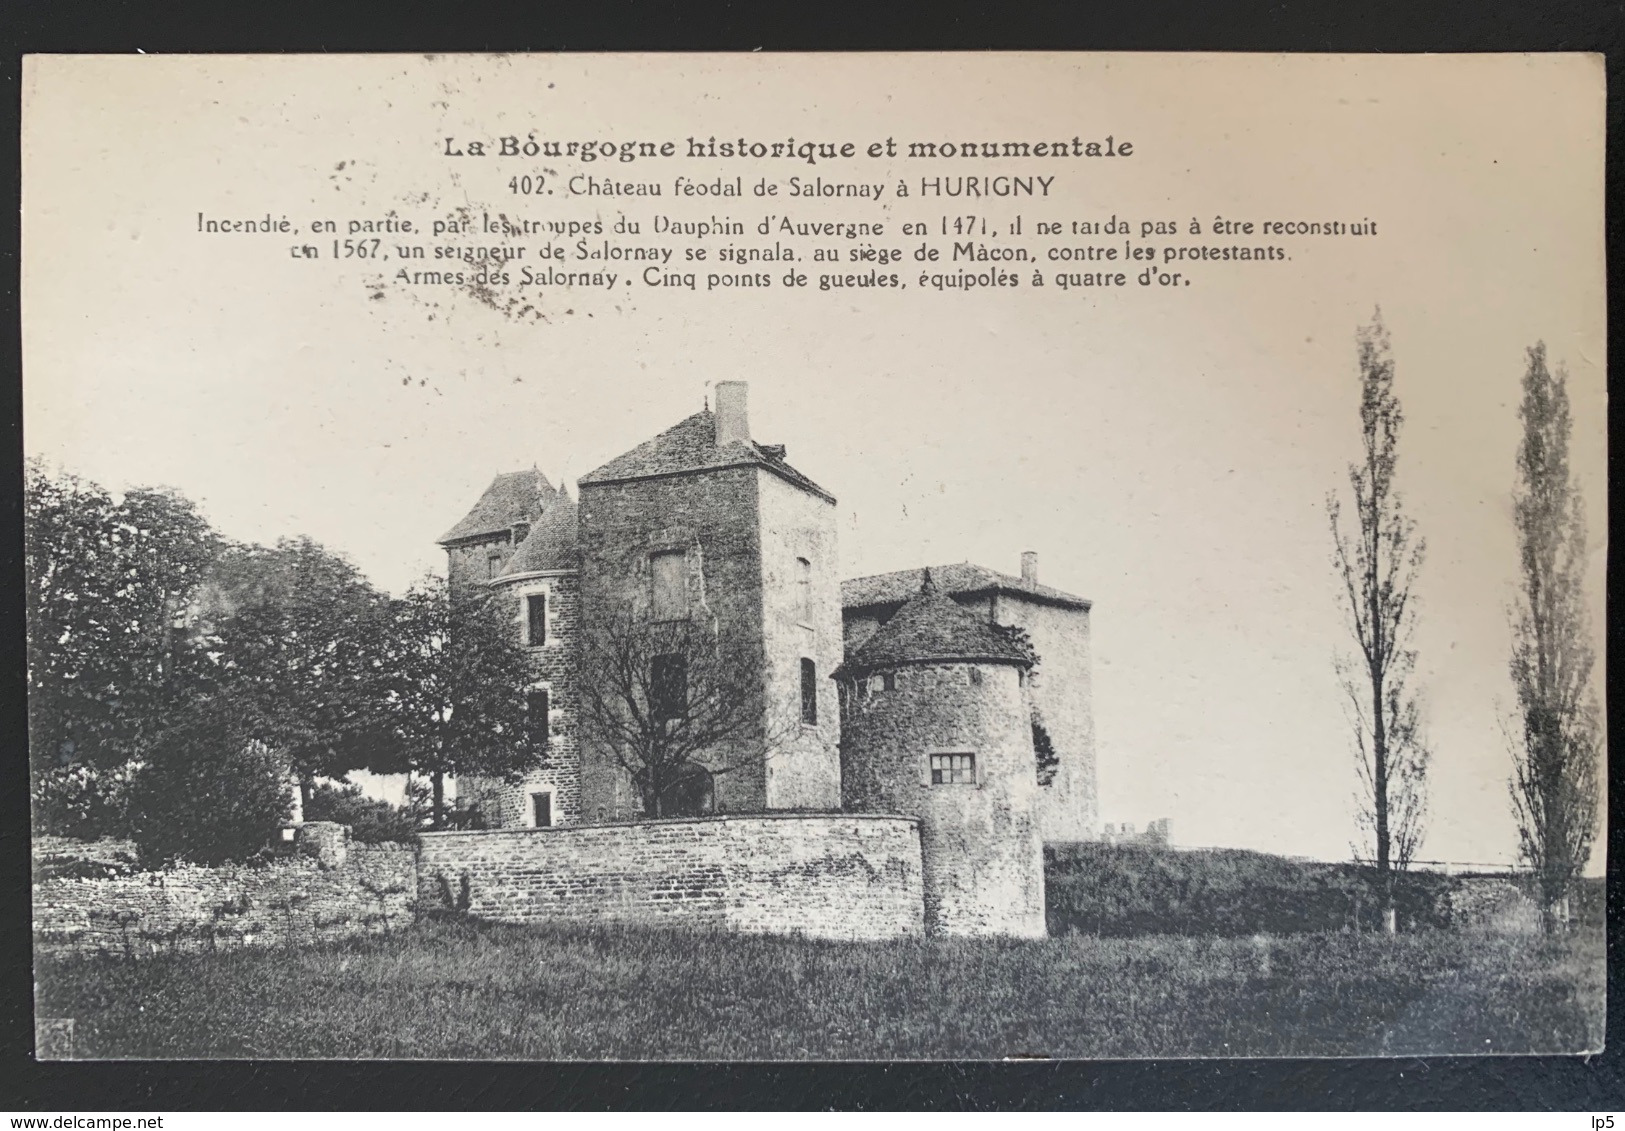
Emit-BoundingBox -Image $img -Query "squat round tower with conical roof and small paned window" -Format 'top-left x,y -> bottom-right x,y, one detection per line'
835,570 -> 1045,938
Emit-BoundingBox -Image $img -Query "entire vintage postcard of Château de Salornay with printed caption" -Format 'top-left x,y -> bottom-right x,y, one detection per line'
23,54 -> 1607,1061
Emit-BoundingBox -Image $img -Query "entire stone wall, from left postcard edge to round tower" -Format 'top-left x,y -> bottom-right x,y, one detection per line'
33,813 -> 925,957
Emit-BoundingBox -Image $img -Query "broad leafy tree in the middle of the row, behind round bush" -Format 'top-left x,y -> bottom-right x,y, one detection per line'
197,538 -> 398,803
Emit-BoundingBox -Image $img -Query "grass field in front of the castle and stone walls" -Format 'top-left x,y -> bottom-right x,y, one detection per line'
36,921 -> 1604,1060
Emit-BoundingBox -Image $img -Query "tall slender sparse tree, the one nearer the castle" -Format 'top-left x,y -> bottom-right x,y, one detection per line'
1326,310 -> 1428,930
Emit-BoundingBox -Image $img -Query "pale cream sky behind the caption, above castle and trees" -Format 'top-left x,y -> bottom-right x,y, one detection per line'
23,55 -> 1606,861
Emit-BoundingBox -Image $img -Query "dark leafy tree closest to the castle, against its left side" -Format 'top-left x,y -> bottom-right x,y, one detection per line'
380,577 -> 541,829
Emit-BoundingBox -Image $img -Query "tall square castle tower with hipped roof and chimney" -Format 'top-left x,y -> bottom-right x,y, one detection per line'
579,382 -> 843,822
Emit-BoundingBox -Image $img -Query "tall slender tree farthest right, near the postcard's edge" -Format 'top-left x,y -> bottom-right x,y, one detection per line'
1510,343 -> 1601,931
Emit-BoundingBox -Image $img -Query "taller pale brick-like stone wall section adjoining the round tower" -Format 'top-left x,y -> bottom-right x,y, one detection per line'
418,813 -> 925,939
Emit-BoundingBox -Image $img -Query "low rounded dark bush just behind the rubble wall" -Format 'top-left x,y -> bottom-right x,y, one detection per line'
130,699 -> 291,866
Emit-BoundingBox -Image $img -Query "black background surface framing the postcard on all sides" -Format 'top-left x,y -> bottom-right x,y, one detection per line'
0,0 -> 1625,1126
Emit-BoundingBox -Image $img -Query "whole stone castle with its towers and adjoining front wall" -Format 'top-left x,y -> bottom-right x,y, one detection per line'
424,382 -> 1097,936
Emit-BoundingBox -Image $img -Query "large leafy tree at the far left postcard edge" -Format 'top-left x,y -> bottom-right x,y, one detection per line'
23,463 -> 221,824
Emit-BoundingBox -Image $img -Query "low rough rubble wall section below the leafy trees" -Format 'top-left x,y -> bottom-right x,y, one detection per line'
34,843 -> 418,957
